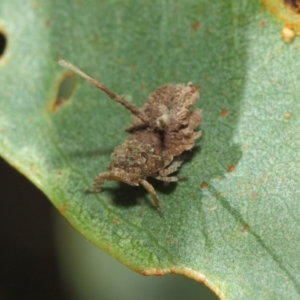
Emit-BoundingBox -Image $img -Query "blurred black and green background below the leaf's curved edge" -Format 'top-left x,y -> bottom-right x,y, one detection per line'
0,158 -> 218,300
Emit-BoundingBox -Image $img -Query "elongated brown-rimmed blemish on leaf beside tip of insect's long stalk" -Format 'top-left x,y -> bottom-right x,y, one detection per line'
50,72 -> 76,112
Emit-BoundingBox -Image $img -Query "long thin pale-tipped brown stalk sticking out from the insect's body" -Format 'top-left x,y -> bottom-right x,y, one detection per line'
58,58 -> 149,124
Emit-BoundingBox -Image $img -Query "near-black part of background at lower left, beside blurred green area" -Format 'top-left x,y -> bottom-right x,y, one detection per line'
0,158 -> 70,300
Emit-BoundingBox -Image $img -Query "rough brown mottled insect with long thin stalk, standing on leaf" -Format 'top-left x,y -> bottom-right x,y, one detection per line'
59,59 -> 201,216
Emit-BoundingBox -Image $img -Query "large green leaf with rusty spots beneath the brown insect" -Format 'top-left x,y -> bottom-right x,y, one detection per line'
0,0 -> 300,299
